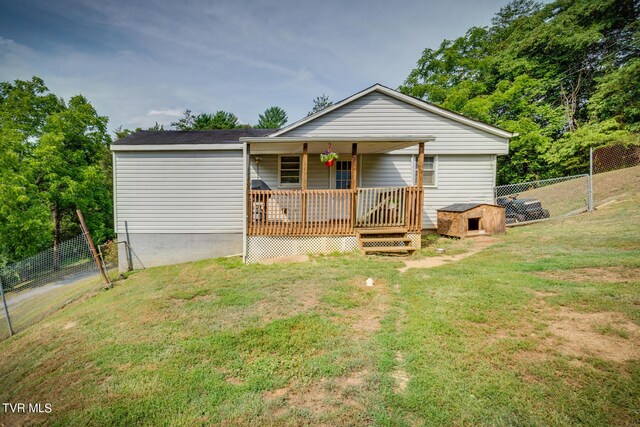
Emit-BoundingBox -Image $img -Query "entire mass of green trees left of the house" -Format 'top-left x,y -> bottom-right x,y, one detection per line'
0,77 -> 112,263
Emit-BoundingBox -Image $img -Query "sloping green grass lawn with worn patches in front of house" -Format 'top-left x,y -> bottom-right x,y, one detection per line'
0,189 -> 640,426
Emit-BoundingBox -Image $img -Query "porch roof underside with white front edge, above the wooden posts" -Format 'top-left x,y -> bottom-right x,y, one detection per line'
240,136 -> 435,154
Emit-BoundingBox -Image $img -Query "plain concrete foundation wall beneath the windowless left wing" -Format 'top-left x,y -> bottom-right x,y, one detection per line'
118,233 -> 242,271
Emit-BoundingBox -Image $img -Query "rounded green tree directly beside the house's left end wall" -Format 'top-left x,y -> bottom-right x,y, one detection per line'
32,95 -> 112,261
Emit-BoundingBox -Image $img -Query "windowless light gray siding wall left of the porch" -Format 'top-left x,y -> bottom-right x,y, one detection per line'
114,150 -> 243,234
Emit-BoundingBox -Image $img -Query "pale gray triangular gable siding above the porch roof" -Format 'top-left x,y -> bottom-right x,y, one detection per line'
281,92 -> 508,154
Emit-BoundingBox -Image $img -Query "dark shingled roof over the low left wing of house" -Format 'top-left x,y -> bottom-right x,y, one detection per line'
113,129 -> 275,145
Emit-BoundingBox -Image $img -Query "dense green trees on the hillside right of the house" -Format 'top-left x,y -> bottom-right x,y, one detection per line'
400,0 -> 640,183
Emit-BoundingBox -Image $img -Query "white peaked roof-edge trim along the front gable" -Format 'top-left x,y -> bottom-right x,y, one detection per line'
269,84 -> 515,139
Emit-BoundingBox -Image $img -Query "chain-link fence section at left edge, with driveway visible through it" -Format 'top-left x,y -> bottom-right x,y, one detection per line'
0,234 -> 102,339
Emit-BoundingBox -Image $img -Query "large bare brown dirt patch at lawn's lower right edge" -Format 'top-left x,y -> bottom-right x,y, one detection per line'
549,307 -> 640,363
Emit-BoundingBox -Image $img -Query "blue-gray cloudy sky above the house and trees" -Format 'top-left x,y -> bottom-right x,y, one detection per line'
0,0 -> 507,129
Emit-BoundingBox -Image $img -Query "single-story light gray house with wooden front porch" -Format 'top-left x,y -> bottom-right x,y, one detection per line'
111,84 -> 514,266
